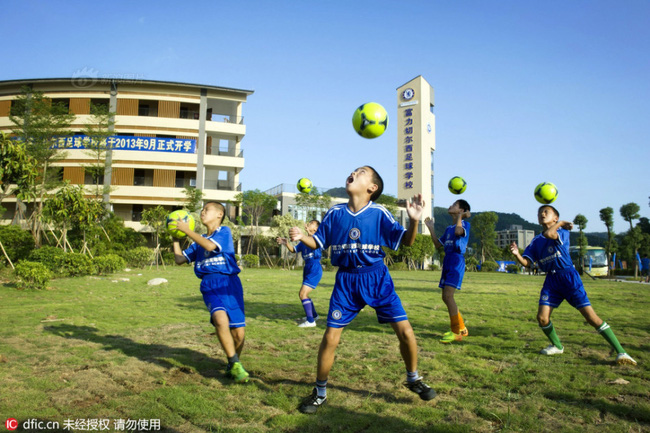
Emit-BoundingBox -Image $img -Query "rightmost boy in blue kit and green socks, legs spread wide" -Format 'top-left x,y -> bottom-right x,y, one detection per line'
510,205 -> 636,365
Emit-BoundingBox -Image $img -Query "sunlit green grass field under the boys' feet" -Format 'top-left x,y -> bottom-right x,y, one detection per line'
0,266 -> 650,432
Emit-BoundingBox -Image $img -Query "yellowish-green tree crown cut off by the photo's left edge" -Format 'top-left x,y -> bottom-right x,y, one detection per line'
0,131 -> 38,215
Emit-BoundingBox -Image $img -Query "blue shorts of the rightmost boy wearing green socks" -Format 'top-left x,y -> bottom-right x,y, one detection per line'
539,268 -> 591,310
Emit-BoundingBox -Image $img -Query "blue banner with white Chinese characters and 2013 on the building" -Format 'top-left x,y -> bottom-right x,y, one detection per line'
52,135 -> 196,153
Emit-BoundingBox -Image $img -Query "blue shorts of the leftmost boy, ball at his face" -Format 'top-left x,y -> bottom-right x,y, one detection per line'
201,274 -> 246,328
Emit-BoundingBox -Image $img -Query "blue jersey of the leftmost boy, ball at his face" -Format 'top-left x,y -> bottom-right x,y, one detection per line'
183,226 -> 239,278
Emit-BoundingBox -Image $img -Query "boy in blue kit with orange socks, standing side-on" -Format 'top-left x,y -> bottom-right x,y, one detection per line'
424,200 -> 470,344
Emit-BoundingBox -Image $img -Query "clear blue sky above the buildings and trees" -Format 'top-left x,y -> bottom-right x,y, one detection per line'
0,0 -> 650,232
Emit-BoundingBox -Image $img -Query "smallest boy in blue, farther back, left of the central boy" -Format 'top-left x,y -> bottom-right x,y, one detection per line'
276,220 -> 323,328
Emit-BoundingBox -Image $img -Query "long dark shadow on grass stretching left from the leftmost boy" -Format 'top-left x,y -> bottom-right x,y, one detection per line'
44,324 -> 230,383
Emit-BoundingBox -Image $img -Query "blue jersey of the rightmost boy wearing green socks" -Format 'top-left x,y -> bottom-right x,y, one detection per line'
523,228 -> 573,272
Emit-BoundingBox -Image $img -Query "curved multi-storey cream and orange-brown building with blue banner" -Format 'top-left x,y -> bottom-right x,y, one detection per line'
0,77 -> 253,231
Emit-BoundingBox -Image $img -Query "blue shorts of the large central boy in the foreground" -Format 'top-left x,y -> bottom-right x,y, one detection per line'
327,262 -> 408,328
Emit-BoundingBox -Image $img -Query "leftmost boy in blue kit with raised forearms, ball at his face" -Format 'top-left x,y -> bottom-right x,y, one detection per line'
174,202 -> 249,382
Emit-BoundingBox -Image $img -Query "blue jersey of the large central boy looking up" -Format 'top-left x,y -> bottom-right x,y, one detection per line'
314,202 -> 406,269
